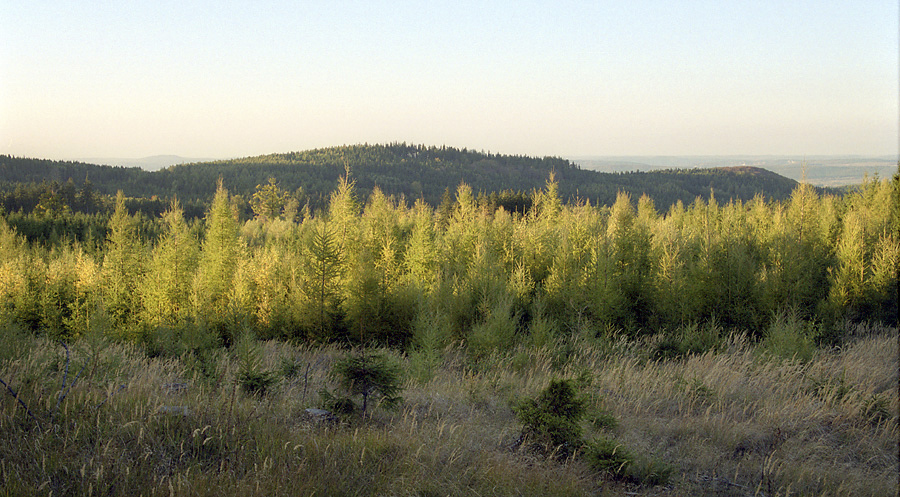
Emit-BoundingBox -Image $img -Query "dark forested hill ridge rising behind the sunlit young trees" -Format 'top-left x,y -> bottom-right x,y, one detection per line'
0,143 -> 816,211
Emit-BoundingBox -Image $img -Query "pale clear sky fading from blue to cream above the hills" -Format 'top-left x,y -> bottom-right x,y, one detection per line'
0,0 -> 900,159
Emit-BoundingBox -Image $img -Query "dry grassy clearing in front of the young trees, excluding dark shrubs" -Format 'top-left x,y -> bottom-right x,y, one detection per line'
0,322 -> 900,496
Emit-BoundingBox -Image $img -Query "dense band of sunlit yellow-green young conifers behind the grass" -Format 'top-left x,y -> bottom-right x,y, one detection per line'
0,171 -> 900,356
